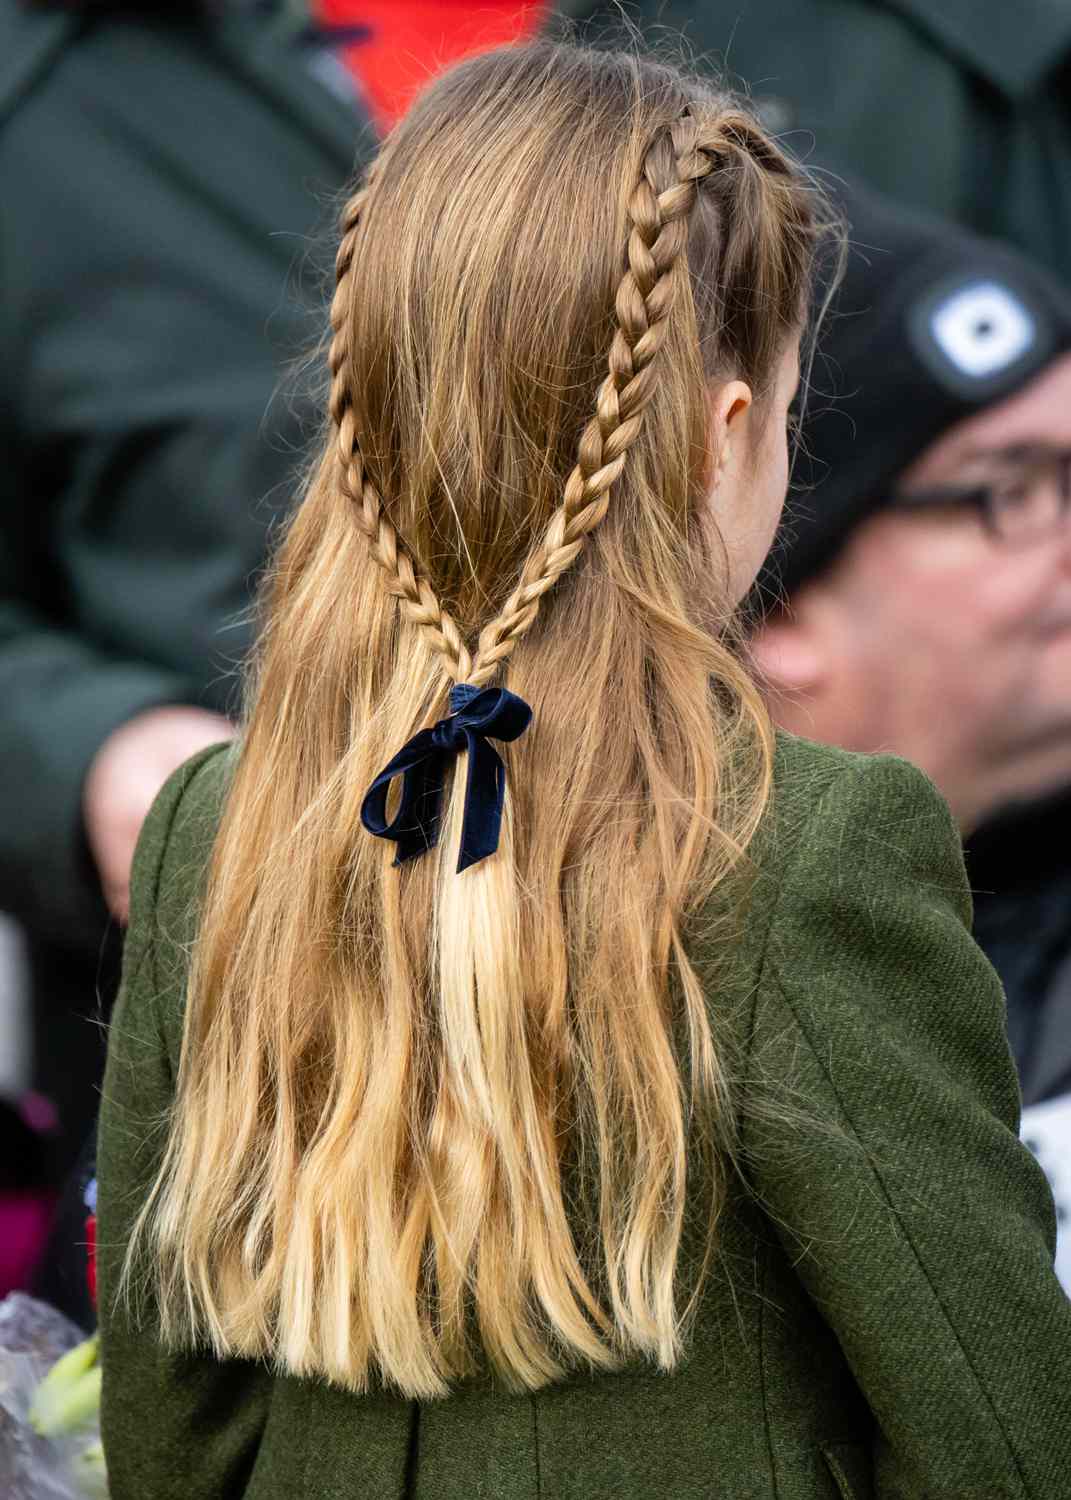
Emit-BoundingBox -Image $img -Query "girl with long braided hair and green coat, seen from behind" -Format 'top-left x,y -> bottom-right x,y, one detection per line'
99,42 -> 1071,1500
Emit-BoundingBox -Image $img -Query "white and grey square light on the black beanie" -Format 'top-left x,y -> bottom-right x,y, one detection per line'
911,275 -> 1052,402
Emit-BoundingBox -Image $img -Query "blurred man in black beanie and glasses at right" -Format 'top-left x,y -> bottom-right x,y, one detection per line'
753,181 -> 1071,1272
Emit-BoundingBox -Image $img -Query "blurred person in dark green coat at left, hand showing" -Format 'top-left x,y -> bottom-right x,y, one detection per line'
0,0 -> 371,1173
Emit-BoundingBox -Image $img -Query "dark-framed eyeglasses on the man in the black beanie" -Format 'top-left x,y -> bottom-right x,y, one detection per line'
887,450 -> 1071,546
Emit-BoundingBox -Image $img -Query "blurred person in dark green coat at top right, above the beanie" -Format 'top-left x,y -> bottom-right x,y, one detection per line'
684,0 -> 1071,282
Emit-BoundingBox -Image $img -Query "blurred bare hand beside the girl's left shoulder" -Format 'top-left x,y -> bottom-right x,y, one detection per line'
83,705 -> 234,923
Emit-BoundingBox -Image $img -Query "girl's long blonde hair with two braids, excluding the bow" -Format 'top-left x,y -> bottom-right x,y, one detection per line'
125,42 -> 816,1398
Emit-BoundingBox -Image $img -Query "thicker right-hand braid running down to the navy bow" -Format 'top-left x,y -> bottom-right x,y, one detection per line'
467,117 -> 728,687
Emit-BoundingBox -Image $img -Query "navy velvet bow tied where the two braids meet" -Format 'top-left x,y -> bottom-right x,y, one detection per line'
360,683 -> 533,873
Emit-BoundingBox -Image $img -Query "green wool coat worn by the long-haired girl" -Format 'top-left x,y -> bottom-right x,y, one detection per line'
99,738 -> 1071,1500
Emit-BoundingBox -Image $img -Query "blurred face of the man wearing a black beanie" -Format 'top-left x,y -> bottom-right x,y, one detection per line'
774,356 -> 1071,824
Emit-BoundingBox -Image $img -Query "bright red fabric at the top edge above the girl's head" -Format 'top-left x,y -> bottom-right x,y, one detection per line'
315,0 -> 551,131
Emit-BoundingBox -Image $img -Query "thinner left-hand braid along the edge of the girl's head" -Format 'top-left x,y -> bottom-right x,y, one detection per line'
327,179 -> 473,683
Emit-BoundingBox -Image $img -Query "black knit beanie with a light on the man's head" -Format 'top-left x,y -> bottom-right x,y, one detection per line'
758,186 -> 1071,602
